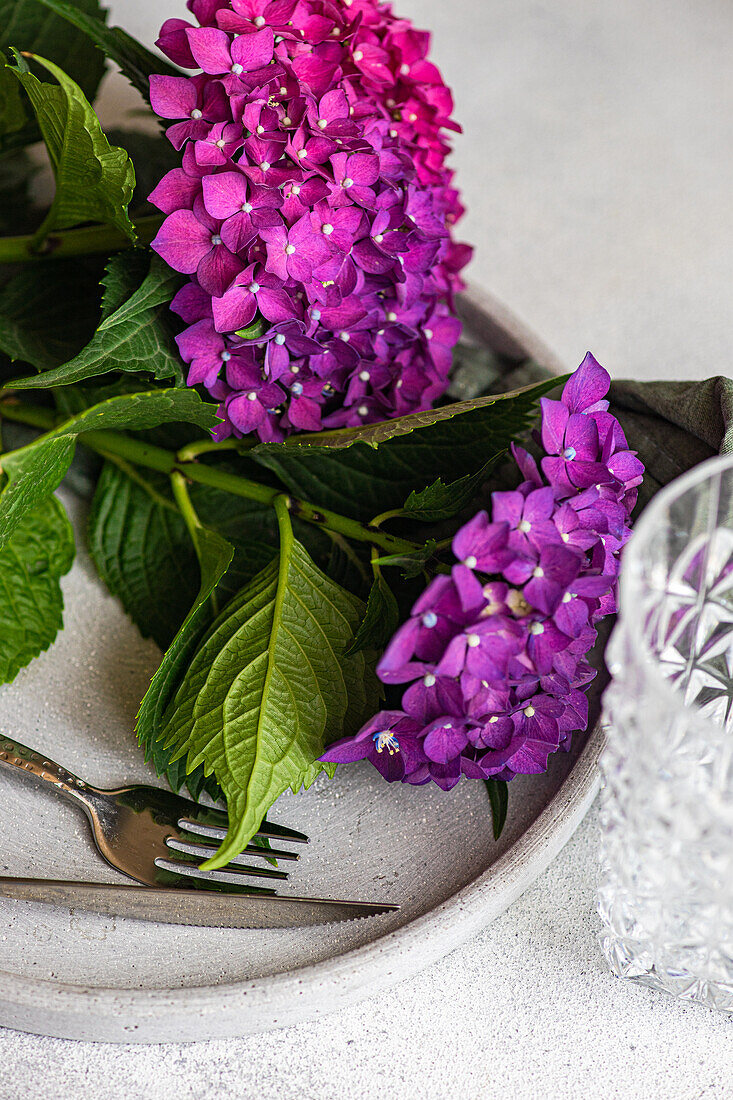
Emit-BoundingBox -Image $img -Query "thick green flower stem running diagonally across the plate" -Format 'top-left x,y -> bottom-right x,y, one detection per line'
0,400 -> 420,554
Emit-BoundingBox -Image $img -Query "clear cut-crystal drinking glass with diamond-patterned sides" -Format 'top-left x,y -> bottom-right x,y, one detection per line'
599,457 -> 733,1012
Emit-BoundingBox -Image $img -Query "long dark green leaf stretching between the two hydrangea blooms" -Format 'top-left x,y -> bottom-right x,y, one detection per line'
249,378 -> 558,520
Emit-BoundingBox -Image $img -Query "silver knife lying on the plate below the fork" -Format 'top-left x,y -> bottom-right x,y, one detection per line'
0,876 -> 400,928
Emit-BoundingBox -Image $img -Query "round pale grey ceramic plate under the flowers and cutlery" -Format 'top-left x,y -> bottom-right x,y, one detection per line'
0,295 -> 602,1043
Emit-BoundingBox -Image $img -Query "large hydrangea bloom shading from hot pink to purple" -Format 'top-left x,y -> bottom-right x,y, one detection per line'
151,0 -> 470,440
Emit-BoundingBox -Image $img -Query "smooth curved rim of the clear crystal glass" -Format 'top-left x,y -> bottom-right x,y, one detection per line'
619,453 -> 733,726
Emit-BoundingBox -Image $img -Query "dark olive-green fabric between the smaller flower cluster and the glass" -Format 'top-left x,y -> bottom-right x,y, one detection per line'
610,375 -> 733,504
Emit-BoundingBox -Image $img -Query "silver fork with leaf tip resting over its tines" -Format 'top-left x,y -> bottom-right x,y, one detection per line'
0,736 -> 308,894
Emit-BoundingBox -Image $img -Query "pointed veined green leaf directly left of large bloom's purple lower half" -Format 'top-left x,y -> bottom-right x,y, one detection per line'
10,249 -> 184,389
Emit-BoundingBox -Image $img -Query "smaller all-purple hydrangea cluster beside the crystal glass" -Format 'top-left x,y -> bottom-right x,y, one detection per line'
321,354 -> 644,790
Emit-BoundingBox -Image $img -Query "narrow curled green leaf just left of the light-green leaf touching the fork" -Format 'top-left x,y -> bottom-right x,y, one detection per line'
135,528 -> 232,798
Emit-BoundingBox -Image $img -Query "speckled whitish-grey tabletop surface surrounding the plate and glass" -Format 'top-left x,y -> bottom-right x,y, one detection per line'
0,0 -> 733,1100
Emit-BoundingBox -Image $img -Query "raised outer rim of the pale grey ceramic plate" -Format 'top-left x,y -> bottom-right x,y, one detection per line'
0,286 -> 605,1043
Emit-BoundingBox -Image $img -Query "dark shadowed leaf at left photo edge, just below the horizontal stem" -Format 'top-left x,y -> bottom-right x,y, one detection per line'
0,260 -> 99,374
